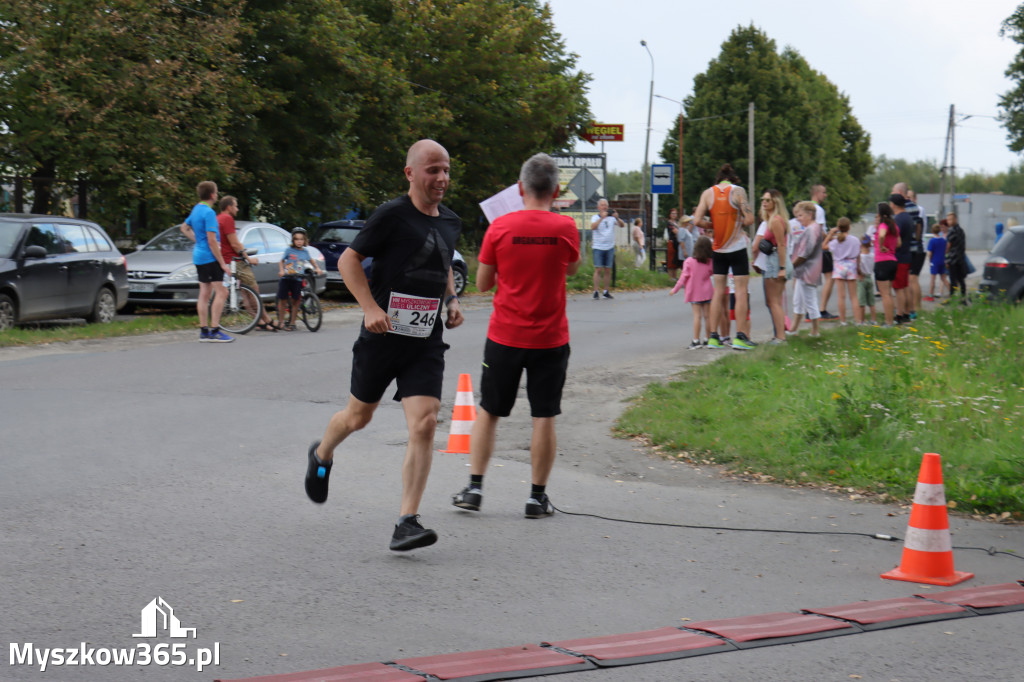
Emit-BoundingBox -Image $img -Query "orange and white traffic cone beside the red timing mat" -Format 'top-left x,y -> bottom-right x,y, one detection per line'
882,453 -> 974,587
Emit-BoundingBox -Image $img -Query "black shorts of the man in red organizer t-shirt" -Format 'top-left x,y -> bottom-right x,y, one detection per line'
480,339 -> 569,418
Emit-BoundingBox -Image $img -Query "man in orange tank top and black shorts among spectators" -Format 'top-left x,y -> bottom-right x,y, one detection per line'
693,164 -> 755,350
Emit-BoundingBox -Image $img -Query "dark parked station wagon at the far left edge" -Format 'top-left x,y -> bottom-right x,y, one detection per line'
0,213 -> 128,330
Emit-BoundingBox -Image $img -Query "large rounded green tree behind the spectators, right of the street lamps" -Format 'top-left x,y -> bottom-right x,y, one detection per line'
662,26 -> 871,217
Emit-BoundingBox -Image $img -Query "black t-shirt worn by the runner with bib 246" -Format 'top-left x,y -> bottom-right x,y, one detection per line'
351,195 -> 462,336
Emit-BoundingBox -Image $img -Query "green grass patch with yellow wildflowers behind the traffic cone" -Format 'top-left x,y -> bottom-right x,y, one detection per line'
616,303 -> 1024,520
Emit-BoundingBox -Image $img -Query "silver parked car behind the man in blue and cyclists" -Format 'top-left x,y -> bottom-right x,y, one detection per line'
126,220 -> 327,307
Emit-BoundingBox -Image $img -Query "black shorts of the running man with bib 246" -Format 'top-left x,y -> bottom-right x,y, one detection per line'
349,334 -> 449,403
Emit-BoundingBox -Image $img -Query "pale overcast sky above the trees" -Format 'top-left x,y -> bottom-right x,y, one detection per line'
549,0 -> 1021,174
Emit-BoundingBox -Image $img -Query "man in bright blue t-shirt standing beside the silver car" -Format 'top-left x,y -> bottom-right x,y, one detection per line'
180,180 -> 234,343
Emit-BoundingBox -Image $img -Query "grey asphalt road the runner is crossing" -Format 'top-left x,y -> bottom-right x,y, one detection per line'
0,268 -> 1024,682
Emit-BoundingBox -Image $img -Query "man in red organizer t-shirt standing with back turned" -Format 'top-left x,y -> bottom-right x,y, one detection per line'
452,154 -> 581,518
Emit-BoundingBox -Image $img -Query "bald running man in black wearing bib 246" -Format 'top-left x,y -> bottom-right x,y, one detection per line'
305,139 -> 463,552
